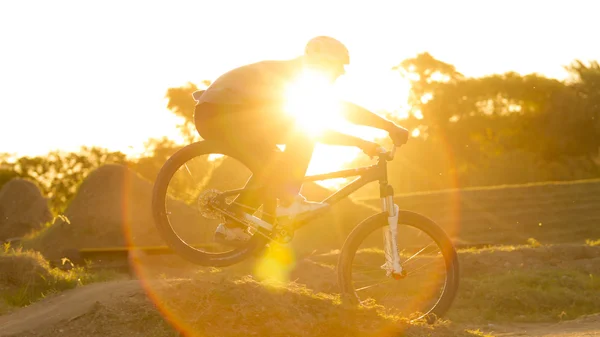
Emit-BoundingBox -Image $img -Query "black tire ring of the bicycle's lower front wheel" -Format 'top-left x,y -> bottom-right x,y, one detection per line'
338,210 -> 459,323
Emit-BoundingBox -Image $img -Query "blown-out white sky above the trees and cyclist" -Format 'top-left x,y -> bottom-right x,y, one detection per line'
0,0 -> 600,159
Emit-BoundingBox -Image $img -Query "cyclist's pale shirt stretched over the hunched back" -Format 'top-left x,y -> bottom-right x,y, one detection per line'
198,59 -> 302,105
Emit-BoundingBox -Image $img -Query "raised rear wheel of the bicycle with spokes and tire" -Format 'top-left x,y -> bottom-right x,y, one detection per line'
152,141 -> 274,267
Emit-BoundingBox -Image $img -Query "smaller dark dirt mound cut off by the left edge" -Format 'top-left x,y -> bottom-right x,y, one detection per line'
0,178 -> 52,242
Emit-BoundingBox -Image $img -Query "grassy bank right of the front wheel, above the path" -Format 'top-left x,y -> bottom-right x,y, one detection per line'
449,242 -> 600,322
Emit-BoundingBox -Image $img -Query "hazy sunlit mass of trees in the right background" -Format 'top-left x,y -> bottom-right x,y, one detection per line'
346,53 -> 600,192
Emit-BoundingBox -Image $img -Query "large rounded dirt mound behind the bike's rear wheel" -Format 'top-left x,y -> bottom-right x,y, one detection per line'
25,164 -> 212,259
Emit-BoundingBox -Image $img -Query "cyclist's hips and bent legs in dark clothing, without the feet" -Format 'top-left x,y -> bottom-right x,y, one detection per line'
195,103 -> 322,215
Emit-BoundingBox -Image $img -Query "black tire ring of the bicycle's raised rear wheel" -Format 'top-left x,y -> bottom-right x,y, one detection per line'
152,140 -> 268,267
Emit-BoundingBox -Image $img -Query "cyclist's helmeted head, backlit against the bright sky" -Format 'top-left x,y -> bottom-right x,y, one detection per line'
304,36 -> 350,80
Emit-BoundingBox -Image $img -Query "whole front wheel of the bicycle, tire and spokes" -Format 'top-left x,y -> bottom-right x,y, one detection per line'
338,210 -> 459,321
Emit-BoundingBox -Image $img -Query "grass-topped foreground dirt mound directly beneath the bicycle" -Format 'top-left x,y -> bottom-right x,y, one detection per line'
0,273 -> 472,337
